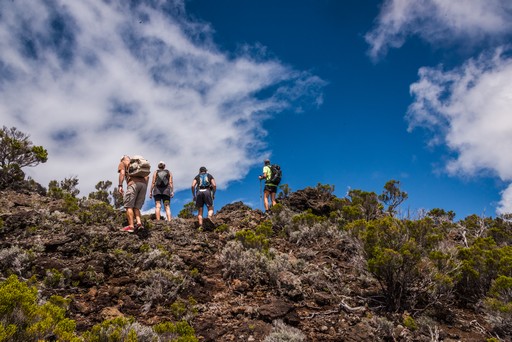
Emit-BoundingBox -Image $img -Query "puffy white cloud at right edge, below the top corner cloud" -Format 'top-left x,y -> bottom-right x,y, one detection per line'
407,48 -> 512,212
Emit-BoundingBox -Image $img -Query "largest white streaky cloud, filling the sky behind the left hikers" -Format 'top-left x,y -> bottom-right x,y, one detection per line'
0,0 -> 323,195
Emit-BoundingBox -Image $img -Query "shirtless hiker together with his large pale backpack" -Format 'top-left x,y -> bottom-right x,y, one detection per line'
117,155 -> 151,233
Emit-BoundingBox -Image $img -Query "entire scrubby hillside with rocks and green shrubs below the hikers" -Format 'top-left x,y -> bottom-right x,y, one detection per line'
0,185 -> 512,341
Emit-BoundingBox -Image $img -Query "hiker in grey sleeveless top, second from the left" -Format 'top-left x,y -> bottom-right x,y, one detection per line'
149,161 -> 174,222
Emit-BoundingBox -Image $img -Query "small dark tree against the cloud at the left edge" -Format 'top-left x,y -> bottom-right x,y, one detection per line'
0,126 -> 48,189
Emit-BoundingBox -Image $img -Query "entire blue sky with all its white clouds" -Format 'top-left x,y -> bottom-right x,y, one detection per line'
0,0 -> 512,219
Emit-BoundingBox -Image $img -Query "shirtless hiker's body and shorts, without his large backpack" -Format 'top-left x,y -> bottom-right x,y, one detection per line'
117,155 -> 148,233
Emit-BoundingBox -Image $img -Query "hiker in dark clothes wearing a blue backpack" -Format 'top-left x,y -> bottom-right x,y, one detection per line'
191,166 -> 217,228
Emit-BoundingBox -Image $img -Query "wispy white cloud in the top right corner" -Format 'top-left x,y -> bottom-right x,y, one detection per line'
365,0 -> 512,59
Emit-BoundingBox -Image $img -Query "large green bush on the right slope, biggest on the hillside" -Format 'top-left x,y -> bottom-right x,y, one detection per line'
360,217 -> 457,311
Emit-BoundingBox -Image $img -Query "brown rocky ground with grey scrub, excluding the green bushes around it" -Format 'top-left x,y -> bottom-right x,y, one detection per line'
0,189 -> 492,341
